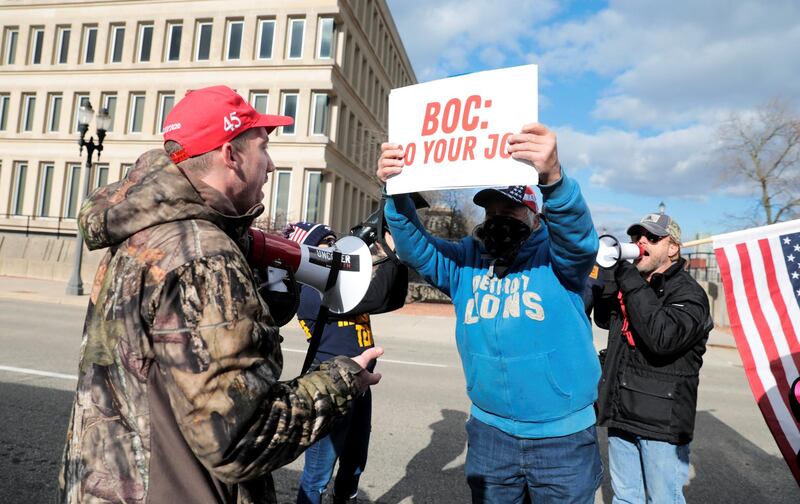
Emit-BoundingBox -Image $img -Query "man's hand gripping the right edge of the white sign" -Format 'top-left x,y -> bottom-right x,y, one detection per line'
508,123 -> 561,185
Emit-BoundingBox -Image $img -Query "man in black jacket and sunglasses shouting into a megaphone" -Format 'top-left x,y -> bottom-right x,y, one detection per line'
595,214 -> 713,503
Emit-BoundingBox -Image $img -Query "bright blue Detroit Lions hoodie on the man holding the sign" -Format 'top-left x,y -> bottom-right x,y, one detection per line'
385,175 -> 600,438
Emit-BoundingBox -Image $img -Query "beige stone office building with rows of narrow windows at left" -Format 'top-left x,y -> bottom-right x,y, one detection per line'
0,0 -> 416,242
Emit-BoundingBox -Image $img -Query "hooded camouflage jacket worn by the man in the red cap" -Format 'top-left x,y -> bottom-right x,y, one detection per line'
59,150 -> 360,503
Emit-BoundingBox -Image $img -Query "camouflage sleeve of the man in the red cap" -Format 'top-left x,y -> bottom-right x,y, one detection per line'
150,256 -> 361,483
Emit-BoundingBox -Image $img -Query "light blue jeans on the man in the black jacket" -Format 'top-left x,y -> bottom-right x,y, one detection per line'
608,429 -> 689,504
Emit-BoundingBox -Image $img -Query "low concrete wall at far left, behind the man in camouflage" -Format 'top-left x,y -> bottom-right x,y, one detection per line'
0,234 -> 104,282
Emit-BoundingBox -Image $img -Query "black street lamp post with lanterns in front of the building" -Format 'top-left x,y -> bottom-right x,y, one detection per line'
67,101 -> 111,296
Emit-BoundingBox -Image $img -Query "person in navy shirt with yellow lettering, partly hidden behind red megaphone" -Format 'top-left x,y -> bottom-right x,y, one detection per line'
284,222 -> 408,504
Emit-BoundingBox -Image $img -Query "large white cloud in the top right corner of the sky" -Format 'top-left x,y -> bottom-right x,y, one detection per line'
534,0 -> 800,129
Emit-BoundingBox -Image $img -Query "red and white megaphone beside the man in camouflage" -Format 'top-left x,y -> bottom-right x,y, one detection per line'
247,228 -> 372,313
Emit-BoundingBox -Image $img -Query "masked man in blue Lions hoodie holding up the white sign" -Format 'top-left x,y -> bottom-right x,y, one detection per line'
377,123 -> 603,504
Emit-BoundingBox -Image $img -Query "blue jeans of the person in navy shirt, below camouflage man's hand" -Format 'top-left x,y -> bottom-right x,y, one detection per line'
297,389 -> 372,504
